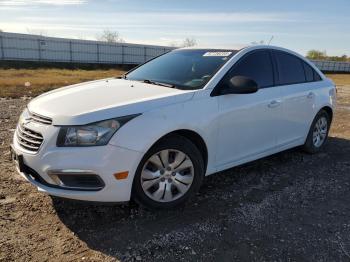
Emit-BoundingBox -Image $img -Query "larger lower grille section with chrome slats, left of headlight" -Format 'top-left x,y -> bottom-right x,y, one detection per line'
16,124 -> 44,153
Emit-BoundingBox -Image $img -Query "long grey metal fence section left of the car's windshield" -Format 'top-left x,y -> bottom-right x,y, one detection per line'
0,32 -> 173,64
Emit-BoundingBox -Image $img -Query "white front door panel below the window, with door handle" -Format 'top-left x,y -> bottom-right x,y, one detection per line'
216,87 -> 283,166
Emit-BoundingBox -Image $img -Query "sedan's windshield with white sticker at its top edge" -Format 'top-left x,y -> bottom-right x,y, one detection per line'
125,50 -> 236,90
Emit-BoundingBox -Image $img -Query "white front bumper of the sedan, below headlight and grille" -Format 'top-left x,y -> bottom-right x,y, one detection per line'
12,130 -> 143,202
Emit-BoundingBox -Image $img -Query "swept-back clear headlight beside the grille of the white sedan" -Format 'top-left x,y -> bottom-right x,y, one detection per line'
57,114 -> 140,147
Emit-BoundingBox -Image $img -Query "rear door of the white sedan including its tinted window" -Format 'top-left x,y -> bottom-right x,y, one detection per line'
273,50 -> 319,146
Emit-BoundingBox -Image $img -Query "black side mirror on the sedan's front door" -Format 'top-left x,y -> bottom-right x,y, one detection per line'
220,76 -> 259,95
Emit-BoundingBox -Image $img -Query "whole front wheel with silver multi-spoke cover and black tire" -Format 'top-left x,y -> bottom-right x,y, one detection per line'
133,135 -> 204,208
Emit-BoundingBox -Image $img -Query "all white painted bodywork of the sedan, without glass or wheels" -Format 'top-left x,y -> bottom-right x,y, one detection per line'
14,46 -> 336,202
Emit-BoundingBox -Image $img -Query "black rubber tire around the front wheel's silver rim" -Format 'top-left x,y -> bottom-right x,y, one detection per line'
132,135 -> 205,209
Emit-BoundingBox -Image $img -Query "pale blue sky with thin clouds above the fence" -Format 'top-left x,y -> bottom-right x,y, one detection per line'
0,0 -> 350,56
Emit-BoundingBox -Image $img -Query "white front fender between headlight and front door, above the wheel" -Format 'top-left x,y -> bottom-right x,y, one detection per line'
110,90 -> 218,174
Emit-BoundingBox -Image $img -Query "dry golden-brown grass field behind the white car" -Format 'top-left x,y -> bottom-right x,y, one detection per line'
0,69 -> 350,98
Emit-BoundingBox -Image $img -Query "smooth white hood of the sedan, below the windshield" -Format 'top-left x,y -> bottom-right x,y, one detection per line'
28,79 -> 194,125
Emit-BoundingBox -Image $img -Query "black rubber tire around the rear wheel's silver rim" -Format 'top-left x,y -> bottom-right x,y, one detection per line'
303,110 -> 331,154
